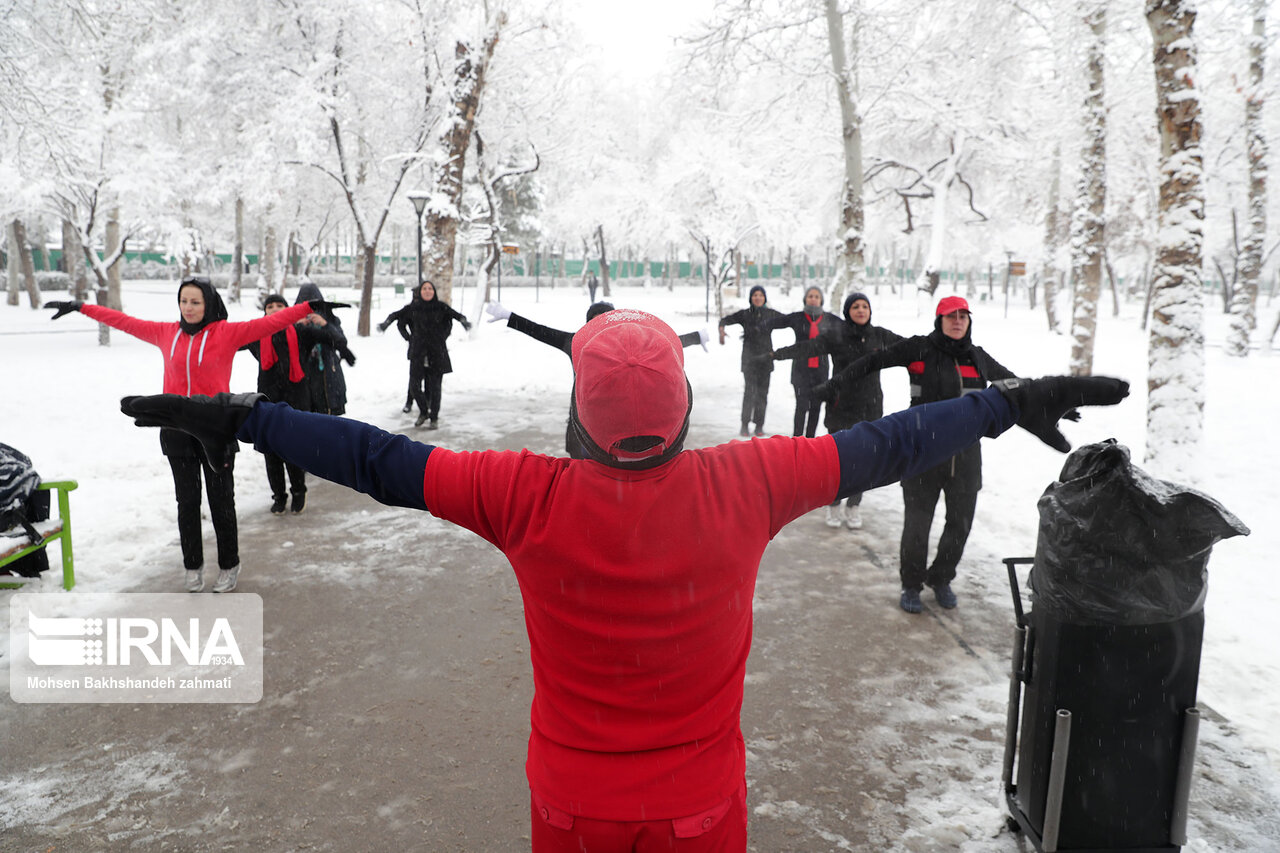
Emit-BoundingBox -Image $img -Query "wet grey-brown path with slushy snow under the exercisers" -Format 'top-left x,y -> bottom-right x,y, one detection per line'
0,392 -> 1280,853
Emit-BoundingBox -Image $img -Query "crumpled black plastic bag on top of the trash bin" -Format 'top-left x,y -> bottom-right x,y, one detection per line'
1030,439 -> 1249,625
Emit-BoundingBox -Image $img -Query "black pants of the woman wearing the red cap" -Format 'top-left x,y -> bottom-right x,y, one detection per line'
899,465 -> 978,589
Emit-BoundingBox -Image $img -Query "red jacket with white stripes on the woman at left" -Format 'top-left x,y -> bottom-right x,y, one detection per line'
81,302 -> 311,397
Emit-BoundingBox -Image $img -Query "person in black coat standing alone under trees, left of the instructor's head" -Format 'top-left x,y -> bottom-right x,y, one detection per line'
378,282 -> 471,429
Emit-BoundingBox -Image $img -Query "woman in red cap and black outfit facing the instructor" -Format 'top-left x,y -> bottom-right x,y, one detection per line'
818,296 -> 1014,613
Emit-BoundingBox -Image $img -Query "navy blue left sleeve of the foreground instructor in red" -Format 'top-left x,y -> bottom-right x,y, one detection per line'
236,402 -> 435,510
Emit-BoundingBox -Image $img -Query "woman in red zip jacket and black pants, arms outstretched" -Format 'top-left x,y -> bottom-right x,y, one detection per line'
45,275 -> 320,592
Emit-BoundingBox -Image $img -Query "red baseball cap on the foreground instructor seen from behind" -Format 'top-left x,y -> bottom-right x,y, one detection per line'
572,309 -> 689,461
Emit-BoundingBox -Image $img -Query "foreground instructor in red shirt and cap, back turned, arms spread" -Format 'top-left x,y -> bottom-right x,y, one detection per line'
120,310 -> 1126,853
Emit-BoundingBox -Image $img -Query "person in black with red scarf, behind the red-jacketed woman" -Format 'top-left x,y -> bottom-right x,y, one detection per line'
243,291 -> 333,515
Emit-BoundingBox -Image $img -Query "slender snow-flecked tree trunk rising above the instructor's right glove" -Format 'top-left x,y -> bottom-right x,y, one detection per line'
1069,0 -> 1107,377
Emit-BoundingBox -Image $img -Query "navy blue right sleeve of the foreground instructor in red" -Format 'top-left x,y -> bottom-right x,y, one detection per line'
832,388 -> 1018,498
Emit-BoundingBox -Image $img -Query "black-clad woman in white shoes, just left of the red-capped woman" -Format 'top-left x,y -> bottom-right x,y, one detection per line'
773,292 -> 902,530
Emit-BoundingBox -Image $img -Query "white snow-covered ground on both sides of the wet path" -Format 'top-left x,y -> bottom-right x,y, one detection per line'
0,275 -> 1280,840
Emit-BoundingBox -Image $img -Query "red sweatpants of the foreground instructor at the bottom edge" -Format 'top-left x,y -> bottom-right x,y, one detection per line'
530,780 -> 746,853
